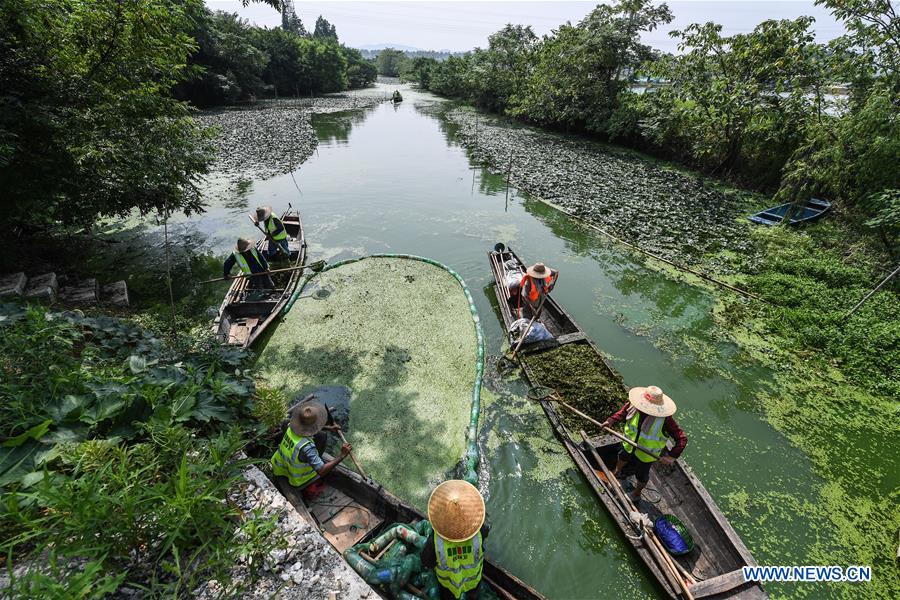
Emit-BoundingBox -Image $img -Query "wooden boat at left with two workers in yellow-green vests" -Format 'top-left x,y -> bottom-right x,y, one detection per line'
213,208 -> 306,348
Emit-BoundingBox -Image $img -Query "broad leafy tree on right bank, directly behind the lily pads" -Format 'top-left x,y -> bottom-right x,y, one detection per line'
642,17 -> 827,186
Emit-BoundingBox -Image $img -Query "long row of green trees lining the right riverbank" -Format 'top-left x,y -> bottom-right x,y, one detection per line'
405,0 -> 900,242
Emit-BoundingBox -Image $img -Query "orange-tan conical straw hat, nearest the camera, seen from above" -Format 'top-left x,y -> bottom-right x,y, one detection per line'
428,479 -> 484,542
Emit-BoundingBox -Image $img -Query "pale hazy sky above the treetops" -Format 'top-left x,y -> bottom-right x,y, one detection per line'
206,0 -> 841,52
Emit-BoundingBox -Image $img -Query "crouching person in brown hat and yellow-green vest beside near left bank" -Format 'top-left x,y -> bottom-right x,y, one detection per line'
270,395 -> 353,490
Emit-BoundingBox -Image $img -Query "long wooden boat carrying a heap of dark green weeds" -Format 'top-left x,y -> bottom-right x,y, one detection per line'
489,244 -> 768,600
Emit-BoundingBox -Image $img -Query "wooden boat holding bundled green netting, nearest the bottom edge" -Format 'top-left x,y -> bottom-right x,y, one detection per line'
275,465 -> 544,600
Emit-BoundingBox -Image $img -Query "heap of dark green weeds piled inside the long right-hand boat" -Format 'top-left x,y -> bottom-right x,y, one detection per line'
523,343 -> 628,439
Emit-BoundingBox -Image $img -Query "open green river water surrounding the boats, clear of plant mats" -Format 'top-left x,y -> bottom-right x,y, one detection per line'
93,83 -> 880,598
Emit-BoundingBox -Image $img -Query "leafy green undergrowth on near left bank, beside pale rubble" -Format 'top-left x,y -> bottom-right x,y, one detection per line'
0,304 -> 270,597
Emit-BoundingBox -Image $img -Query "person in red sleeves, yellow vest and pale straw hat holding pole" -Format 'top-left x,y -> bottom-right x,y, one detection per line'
603,385 -> 687,504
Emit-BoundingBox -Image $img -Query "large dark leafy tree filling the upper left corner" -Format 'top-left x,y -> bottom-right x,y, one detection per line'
0,0 -> 212,231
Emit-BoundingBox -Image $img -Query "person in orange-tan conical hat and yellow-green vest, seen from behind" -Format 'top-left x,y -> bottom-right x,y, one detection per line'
421,479 -> 490,600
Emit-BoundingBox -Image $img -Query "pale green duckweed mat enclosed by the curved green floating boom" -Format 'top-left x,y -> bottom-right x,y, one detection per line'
258,257 -> 480,508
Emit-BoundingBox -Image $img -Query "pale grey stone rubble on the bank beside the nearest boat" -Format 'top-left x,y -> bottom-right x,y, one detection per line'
193,467 -> 379,600
